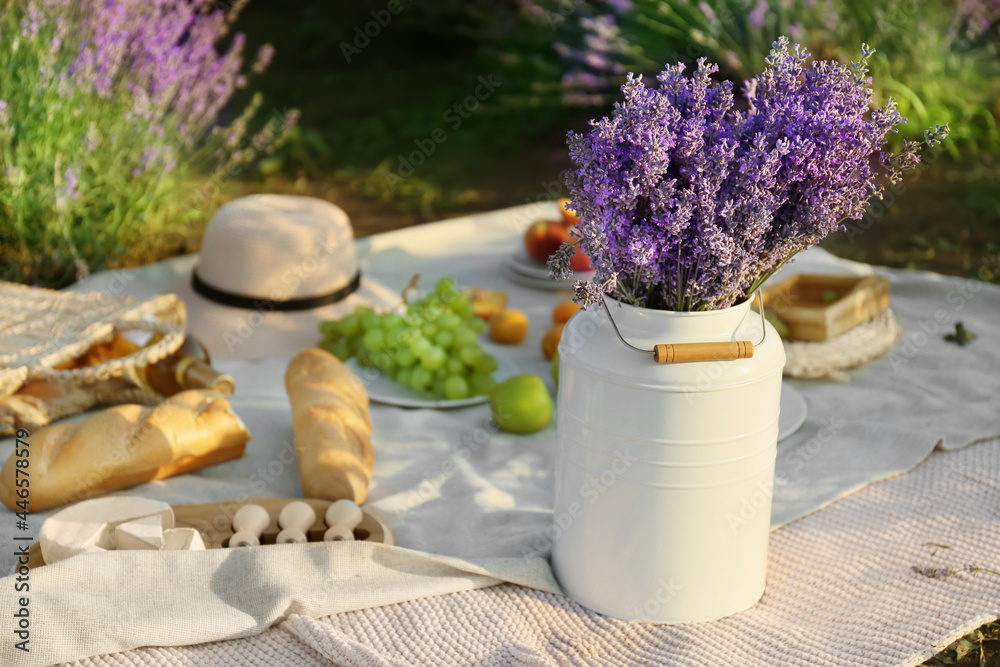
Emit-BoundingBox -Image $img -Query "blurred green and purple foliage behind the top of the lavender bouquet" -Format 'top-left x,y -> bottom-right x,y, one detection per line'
536,0 -> 1000,155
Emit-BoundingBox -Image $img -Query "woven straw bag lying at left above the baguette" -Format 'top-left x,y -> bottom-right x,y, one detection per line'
0,281 -> 186,398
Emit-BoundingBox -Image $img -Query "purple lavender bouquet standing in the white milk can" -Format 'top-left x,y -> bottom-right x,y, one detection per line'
549,38 -> 947,311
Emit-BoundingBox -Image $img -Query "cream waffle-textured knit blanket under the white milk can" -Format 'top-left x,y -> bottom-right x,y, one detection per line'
47,443 -> 1000,667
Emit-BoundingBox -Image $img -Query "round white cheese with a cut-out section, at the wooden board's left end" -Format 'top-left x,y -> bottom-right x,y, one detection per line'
38,496 -> 174,563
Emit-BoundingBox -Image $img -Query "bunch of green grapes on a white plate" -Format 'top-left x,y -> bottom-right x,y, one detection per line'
319,278 -> 497,400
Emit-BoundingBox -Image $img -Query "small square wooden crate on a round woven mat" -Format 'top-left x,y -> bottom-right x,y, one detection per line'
763,273 -> 889,341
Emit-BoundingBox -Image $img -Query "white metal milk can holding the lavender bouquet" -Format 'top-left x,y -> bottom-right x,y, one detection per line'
552,297 -> 785,623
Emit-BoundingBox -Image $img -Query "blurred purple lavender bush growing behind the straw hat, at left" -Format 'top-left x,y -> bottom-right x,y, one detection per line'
0,0 -> 297,287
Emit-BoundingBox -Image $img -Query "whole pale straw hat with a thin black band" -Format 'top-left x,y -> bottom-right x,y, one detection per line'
171,195 -> 400,359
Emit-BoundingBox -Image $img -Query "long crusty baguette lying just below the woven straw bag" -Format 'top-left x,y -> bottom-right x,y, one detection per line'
0,389 -> 250,512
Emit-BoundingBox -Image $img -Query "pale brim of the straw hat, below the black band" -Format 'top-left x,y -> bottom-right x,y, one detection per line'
165,274 -> 402,360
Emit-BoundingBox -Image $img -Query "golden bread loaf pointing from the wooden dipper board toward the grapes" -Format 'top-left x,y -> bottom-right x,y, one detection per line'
285,348 -> 375,505
